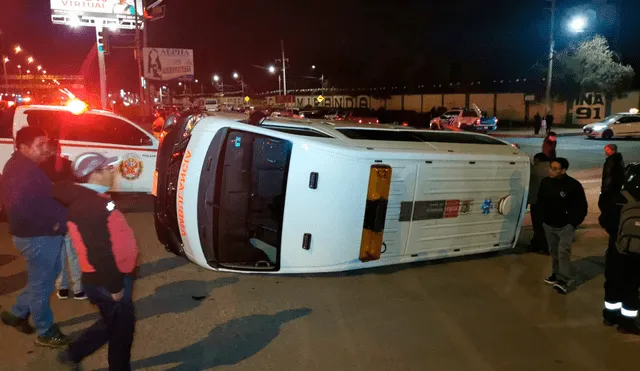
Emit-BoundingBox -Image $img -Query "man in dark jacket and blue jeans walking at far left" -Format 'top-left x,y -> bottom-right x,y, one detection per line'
2,126 -> 68,348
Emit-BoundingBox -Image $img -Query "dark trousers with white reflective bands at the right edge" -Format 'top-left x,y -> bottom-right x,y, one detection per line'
604,234 -> 640,324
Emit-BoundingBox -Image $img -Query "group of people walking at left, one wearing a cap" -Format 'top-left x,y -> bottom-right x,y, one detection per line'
0,126 -> 138,370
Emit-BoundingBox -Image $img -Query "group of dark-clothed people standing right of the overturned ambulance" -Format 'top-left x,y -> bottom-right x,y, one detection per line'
528,136 -> 640,335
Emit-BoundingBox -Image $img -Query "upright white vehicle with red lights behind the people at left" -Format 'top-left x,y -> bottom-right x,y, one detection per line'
0,100 -> 158,193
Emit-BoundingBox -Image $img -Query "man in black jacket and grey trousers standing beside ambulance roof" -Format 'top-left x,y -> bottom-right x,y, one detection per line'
538,157 -> 588,294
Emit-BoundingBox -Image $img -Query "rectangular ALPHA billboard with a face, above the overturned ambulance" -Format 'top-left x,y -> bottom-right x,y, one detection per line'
143,48 -> 194,81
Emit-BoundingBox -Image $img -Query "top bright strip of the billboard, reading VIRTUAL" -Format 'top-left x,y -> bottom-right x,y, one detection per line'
51,0 -> 144,17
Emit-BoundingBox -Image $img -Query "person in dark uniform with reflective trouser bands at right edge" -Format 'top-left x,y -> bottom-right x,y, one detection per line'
599,164 -> 640,335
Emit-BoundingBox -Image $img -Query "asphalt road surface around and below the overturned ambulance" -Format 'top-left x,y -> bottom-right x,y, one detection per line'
0,138 -> 640,371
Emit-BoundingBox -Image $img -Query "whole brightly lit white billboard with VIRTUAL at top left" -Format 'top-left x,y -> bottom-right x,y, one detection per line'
50,0 -> 144,28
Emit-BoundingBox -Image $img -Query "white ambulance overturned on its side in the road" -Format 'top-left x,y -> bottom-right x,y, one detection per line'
154,113 -> 529,273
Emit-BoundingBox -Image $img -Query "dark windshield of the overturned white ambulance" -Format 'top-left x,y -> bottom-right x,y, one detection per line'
213,130 -> 292,270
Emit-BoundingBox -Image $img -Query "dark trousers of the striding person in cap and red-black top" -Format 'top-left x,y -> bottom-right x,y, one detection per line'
69,277 -> 136,371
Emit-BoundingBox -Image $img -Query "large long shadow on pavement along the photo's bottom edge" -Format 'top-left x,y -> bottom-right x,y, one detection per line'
117,308 -> 311,371
